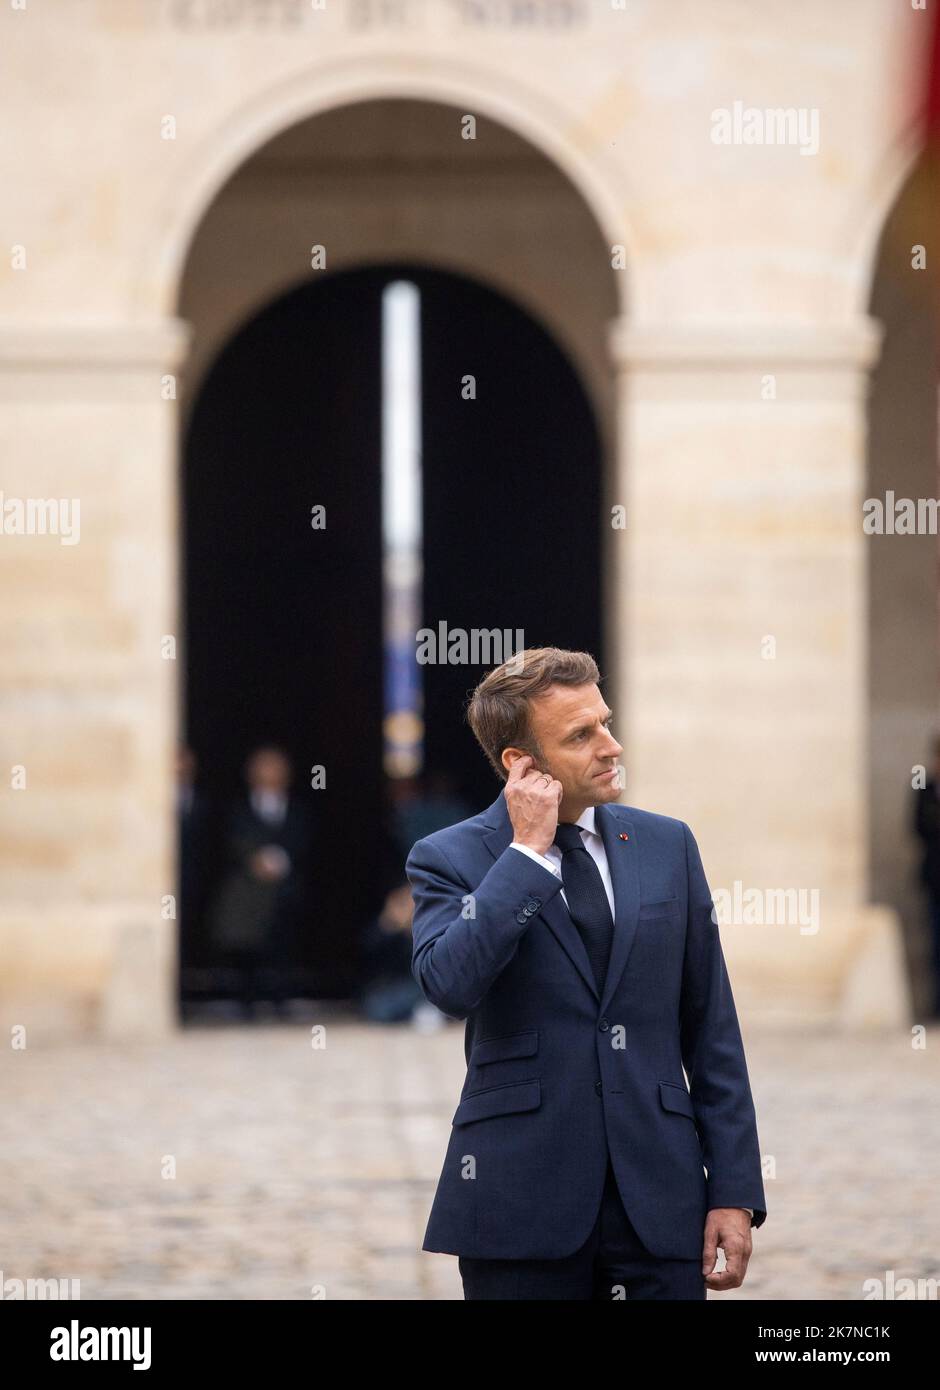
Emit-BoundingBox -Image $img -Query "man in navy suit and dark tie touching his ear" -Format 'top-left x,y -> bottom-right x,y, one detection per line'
406,648 -> 766,1300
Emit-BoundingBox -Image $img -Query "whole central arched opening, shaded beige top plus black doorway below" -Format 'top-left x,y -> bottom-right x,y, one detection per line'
179,101 -> 616,999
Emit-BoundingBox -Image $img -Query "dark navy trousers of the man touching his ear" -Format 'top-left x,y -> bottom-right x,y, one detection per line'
457,1156 -> 705,1302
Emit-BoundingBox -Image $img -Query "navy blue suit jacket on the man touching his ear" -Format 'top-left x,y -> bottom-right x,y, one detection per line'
406,791 -> 766,1259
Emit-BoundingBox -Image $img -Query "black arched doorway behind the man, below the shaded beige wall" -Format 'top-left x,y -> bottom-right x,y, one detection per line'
181,264 -> 603,999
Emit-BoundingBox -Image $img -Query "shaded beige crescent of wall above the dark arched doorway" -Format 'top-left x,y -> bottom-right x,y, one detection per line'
168,76 -> 623,1034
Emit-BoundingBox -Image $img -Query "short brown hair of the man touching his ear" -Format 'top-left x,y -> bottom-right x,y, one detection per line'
467,646 -> 601,781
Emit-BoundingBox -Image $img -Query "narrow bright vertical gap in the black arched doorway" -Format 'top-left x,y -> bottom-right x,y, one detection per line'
382,279 -> 424,777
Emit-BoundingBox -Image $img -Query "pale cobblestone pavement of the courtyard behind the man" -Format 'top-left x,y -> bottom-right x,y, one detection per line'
0,1005 -> 940,1300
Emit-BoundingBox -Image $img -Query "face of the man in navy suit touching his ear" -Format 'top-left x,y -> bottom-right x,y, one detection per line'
511,685 -> 623,806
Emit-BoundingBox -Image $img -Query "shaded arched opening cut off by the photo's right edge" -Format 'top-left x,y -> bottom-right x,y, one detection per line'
865,152 -> 940,1017
